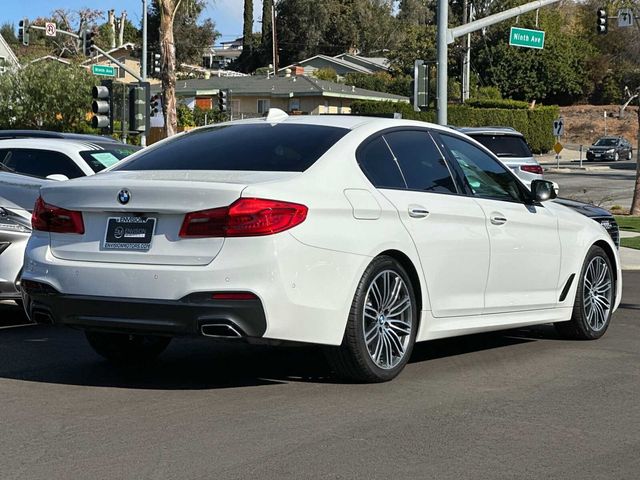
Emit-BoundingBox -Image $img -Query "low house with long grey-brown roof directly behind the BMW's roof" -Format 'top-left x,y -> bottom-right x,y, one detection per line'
159,75 -> 409,119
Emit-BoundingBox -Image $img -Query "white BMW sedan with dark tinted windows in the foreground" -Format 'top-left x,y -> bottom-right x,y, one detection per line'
21,111 -> 622,382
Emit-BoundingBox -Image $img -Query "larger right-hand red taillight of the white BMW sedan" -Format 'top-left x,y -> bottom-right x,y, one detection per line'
180,198 -> 307,237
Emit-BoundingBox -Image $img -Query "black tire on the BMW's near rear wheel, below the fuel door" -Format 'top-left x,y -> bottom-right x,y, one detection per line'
325,256 -> 419,383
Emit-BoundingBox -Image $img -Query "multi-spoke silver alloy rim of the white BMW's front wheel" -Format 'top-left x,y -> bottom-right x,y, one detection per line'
582,256 -> 613,332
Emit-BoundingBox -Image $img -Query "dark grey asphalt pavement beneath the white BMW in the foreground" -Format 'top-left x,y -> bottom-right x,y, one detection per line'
0,272 -> 640,480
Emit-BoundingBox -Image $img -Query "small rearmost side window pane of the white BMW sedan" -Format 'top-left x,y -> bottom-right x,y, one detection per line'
358,137 -> 407,190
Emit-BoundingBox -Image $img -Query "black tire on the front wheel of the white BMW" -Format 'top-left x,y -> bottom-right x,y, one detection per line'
555,245 -> 616,340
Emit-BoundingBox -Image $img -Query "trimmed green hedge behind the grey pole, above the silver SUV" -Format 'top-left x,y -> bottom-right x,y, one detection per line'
351,100 -> 560,153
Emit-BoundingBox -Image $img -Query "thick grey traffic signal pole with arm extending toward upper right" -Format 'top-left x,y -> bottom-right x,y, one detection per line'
436,0 -> 560,125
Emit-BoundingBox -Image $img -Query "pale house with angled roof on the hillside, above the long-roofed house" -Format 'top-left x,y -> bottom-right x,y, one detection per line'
279,53 -> 389,78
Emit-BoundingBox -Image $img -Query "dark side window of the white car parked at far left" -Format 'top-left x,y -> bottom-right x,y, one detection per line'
0,148 -> 84,178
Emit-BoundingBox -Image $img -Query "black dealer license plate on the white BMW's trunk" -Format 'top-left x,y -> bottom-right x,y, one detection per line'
103,217 -> 156,251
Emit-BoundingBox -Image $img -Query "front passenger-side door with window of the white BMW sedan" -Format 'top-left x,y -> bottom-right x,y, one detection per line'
439,134 -> 562,313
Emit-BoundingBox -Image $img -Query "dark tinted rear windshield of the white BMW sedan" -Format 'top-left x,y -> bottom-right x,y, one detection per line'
114,123 -> 349,172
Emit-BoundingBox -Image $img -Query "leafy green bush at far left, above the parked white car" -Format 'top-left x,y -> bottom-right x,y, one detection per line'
0,62 -> 96,132
